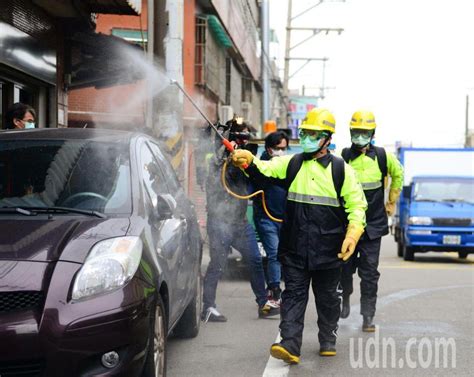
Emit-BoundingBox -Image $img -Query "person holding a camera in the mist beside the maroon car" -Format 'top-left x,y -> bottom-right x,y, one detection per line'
202,119 -> 280,322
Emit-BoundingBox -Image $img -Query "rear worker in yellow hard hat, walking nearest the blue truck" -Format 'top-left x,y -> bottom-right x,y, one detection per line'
341,110 -> 403,332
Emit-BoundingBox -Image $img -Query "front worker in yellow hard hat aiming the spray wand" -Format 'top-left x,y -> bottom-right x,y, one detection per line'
232,108 -> 367,364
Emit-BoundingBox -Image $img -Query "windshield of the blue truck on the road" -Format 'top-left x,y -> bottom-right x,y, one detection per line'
414,179 -> 474,203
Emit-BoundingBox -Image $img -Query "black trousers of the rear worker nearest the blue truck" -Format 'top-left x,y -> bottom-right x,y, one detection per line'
341,237 -> 382,317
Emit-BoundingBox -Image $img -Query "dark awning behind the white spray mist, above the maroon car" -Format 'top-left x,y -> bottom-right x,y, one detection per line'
65,31 -> 146,89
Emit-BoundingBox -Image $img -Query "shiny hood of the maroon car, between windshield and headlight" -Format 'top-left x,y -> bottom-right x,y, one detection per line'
0,216 -> 130,263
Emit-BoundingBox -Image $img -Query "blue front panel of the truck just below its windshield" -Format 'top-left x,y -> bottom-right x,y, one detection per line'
410,202 -> 474,218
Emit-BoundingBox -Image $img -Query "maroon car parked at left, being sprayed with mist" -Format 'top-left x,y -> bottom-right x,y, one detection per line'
0,129 -> 202,377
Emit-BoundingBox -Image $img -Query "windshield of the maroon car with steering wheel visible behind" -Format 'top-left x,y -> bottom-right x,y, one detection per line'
0,140 -> 132,214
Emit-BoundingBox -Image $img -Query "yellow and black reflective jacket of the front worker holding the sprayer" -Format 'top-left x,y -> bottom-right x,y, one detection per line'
252,154 -> 367,270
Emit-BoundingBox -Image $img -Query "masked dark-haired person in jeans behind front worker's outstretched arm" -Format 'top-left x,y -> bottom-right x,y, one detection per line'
253,131 -> 289,303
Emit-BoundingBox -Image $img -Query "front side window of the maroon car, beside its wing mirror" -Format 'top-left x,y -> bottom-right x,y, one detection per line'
140,143 -> 169,206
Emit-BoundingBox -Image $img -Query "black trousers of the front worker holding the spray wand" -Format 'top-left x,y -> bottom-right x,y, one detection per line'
280,265 -> 341,356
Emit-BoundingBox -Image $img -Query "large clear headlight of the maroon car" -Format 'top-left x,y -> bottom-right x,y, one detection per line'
72,237 -> 143,300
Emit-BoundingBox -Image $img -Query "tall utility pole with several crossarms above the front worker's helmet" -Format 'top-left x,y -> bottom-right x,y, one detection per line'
280,0 -> 345,128
